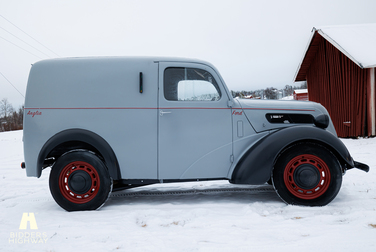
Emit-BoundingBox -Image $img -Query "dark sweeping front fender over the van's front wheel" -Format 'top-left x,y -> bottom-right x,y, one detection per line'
230,126 -> 354,185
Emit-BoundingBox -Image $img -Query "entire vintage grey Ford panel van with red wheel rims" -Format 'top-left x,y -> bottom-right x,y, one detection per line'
22,57 -> 369,211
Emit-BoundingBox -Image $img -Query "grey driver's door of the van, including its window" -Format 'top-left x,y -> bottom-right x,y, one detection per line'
158,62 -> 232,180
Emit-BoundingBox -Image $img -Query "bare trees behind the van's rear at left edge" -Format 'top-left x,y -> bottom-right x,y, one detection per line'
0,98 -> 24,132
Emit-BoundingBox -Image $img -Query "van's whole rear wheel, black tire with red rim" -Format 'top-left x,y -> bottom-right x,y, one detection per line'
49,150 -> 112,211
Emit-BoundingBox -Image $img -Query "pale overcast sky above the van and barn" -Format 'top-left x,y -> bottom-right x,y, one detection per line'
0,0 -> 376,108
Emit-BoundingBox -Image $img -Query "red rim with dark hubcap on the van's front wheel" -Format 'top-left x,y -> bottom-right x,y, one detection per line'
283,154 -> 330,200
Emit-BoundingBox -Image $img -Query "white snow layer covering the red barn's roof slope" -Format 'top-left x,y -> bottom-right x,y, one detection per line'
312,24 -> 376,68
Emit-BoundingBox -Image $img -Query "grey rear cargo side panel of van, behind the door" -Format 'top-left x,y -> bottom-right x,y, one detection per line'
24,58 -> 158,179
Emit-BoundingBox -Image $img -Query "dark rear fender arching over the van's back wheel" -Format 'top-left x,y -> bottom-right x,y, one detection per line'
37,129 -> 121,180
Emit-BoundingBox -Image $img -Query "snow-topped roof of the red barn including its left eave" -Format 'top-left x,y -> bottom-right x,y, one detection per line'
294,24 -> 376,81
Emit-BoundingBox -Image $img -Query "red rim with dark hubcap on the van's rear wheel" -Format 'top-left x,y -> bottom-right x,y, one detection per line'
59,161 -> 100,204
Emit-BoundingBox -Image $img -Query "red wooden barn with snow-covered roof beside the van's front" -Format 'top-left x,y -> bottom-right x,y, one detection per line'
295,24 -> 376,137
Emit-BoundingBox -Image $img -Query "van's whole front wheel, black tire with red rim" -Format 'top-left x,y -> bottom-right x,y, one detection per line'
272,143 -> 342,206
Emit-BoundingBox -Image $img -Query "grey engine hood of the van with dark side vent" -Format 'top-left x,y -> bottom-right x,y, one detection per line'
233,99 -> 336,135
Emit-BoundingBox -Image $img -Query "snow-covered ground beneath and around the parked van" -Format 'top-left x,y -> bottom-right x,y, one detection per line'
0,131 -> 376,252
